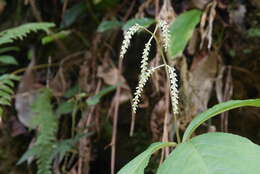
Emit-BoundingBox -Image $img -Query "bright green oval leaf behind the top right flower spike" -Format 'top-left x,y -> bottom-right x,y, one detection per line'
169,10 -> 201,58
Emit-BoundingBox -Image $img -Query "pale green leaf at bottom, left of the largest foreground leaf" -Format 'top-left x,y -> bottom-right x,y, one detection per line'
117,142 -> 176,174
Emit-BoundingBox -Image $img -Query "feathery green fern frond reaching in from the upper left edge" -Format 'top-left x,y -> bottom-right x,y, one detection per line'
0,22 -> 55,45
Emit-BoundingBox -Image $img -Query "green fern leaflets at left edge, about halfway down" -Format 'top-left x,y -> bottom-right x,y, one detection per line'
0,74 -> 20,116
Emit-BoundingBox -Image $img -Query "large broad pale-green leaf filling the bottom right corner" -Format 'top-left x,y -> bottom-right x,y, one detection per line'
157,133 -> 260,174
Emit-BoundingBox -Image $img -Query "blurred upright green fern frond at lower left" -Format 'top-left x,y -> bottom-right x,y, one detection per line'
32,89 -> 58,174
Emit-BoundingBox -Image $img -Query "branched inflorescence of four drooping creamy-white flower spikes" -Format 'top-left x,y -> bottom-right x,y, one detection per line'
120,20 -> 179,114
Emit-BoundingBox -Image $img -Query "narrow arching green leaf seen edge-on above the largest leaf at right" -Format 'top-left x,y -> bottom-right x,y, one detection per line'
182,99 -> 260,142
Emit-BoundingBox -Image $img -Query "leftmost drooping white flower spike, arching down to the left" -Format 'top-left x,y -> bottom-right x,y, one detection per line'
120,24 -> 140,58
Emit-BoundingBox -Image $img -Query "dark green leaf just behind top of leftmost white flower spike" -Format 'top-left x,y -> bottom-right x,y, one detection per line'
123,18 -> 155,30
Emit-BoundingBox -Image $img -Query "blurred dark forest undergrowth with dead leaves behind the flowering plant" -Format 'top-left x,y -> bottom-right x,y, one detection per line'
0,0 -> 260,174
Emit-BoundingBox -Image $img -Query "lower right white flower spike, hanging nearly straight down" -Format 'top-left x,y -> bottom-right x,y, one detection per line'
167,66 -> 179,114
